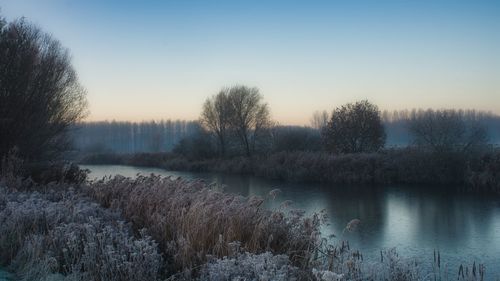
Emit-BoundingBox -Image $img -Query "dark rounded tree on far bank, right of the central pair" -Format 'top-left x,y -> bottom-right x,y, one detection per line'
322,100 -> 386,153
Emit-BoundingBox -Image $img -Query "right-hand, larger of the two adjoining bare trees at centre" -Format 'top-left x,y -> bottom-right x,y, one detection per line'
228,86 -> 271,156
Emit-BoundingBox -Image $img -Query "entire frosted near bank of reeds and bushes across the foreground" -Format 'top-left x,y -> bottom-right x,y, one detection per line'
0,172 -> 492,281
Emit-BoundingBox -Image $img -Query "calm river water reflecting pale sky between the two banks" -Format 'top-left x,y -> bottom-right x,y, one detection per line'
82,165 -> 500,280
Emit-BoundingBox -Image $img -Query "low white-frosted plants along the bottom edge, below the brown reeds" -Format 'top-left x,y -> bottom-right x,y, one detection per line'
199,242 -> 426,281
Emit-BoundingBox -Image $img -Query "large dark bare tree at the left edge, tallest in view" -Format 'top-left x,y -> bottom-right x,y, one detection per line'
0,19 -> 87,160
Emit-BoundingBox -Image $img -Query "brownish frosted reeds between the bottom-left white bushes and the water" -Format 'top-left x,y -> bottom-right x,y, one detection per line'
91,176 -> 322,273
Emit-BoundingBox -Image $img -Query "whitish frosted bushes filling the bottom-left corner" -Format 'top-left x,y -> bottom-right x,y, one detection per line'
0,183 -> 162,280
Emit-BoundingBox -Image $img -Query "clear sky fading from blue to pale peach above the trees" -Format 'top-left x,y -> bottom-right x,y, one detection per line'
0,0 -> 500,125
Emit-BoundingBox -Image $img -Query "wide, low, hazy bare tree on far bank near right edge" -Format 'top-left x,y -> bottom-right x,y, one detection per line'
408,110 -> 488,152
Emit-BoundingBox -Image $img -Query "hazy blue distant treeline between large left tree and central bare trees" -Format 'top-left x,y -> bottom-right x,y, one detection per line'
72,120 -> 200,153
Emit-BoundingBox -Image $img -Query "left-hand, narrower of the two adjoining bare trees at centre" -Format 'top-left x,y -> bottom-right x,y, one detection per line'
200,89 -> 232,156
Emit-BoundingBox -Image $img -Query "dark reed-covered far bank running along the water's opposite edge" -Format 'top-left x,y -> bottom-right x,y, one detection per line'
81,148 -> 500,193
